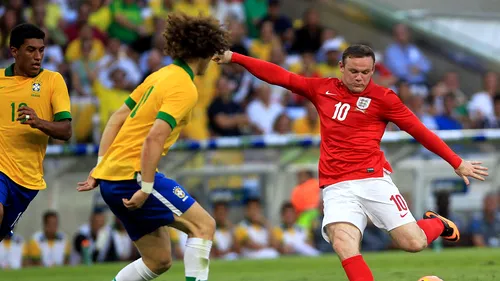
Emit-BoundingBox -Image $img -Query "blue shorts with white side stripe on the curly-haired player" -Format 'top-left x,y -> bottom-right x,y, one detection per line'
100,173 -> 196,241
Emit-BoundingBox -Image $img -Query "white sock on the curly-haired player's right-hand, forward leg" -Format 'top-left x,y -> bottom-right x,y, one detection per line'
186,238 -> 212,281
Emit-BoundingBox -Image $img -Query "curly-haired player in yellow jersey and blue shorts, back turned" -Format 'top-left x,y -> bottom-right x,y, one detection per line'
78,13 -> 229,281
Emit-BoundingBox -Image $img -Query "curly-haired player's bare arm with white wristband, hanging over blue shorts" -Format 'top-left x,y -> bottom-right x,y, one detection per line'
123,119 -> 172,210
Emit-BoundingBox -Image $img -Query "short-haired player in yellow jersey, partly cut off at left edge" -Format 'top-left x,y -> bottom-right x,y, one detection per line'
0,24 -> 71,241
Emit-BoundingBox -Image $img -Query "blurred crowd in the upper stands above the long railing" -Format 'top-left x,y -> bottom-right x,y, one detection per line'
0,0 -> 500,143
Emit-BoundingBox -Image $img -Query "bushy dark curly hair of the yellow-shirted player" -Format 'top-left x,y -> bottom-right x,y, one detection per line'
163,13 -> 229,60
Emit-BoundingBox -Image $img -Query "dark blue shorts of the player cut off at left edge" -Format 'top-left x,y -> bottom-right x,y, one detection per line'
0,173 -> 38,237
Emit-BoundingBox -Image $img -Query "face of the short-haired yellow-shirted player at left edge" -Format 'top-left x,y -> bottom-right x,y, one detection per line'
11,39 -> 45,77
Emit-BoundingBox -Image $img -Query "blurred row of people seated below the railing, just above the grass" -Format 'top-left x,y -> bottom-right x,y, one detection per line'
0,170 -> 500,269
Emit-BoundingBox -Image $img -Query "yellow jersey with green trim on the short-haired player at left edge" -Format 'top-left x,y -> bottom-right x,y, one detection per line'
0,64 -> 71,190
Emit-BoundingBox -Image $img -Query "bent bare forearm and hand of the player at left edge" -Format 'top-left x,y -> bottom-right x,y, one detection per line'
17,106 -> 72,141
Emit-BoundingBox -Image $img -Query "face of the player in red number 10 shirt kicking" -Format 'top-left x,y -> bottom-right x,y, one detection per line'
340,57 -> 374,93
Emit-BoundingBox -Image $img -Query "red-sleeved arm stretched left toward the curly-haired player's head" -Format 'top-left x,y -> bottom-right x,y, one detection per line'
213,51 -> 318,96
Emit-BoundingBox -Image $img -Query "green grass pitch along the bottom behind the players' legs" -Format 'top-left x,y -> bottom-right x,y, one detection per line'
0,249 -> 500,281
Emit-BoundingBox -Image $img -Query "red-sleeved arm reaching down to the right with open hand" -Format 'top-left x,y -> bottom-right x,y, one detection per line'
383,92 -> 488,185
